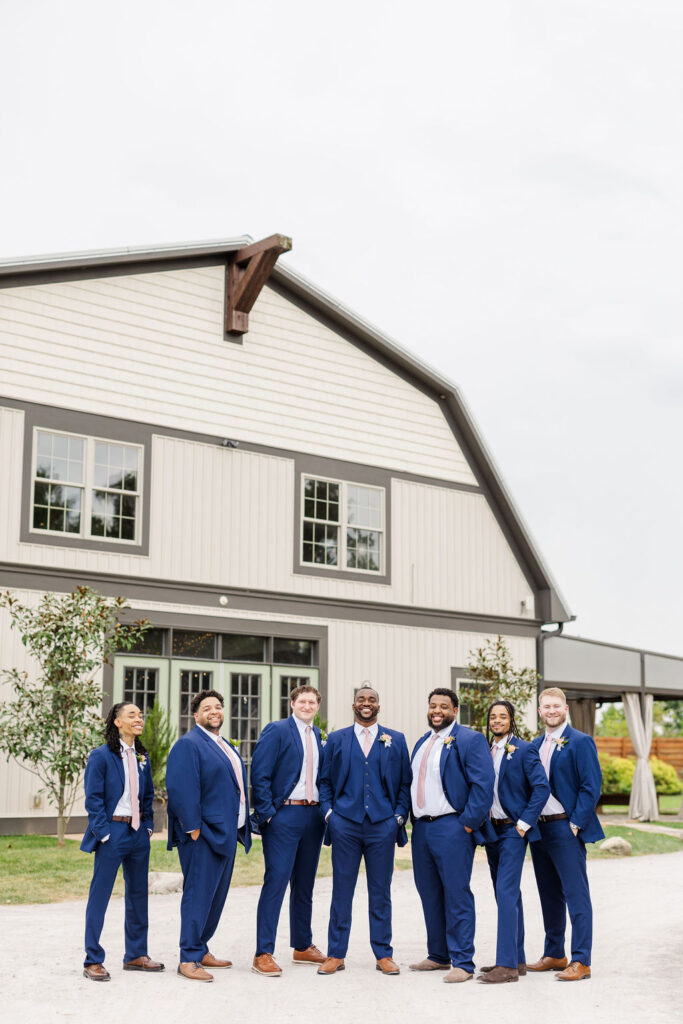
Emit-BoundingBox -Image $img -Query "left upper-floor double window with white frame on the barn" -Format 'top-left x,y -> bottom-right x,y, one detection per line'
31,429 -> 142,544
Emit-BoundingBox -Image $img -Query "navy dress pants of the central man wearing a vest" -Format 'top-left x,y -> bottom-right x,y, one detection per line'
328,811 -> 398,959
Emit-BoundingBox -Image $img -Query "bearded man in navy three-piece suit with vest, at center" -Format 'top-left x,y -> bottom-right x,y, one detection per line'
317,685 -> 411,975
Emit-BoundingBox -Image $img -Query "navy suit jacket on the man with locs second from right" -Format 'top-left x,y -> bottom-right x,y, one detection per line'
492,736 -> 550,843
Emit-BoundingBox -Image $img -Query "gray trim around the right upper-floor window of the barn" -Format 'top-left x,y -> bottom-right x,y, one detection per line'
292,455 -> 392,587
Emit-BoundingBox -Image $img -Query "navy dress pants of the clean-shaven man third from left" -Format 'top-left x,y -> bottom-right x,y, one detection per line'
256,805 -> 325,956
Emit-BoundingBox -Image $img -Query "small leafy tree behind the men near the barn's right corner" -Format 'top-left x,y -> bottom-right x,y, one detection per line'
462,636 -> 541,739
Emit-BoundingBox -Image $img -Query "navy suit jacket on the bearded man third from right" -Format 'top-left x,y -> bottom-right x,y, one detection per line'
411,722 -> 496,843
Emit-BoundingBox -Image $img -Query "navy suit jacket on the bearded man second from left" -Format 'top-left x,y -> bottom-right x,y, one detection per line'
166,726 -> 251,857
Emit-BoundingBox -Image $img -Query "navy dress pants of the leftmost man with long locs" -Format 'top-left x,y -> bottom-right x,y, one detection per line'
84,821 -> 150,967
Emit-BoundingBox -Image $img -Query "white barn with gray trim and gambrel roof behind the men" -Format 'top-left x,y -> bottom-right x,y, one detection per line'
0,236 -> 570,835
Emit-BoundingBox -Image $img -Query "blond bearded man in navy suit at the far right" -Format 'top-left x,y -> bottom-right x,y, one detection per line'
526,686 -> 604,981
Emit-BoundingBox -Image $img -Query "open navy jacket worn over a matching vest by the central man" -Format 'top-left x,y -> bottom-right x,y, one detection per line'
319,725 -> 411,846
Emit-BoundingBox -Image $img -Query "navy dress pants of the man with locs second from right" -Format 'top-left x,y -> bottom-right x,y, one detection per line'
486,825 -> 527,969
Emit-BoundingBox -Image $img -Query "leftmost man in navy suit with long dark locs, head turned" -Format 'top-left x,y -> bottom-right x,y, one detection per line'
81,701 -> 164,981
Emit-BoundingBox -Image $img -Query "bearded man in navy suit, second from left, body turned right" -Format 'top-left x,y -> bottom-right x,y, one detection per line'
166,690 -> 251,981
